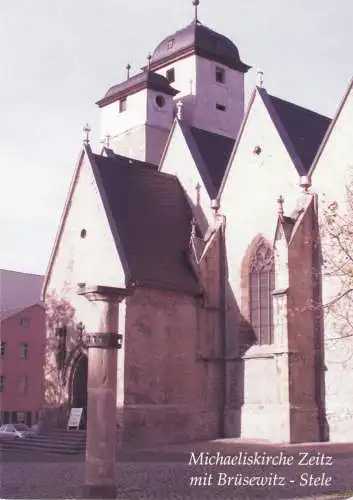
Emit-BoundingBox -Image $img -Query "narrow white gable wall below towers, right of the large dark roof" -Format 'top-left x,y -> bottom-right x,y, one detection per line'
160,124 -> 213,229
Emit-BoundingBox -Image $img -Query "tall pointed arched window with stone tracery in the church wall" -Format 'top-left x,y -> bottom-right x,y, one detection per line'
249,241 -> 275,344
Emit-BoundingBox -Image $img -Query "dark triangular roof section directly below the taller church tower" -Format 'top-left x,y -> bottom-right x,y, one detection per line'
179,121 -> 235,199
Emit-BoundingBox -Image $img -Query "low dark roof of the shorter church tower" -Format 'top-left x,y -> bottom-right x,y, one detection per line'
96,70 -> 179,107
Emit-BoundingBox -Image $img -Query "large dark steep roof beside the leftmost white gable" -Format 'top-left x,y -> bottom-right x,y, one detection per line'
92,154 -> 200,294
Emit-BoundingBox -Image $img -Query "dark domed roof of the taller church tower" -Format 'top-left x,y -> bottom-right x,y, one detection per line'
151,19 -> 251,73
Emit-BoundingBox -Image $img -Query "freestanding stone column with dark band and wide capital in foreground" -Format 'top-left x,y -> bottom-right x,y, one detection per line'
78,286 -> 128,499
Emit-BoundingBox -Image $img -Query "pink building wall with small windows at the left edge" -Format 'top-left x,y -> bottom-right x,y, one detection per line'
0,304 -> 45,425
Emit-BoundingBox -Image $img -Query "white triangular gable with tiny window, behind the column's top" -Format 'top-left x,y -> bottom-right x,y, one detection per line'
43,146 -> 125,296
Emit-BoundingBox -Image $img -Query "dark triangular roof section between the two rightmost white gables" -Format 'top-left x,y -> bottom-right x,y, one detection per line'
268,95 -> 331,175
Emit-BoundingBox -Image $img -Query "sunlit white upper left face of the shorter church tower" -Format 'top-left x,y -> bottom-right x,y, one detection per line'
100,89 -> 147,140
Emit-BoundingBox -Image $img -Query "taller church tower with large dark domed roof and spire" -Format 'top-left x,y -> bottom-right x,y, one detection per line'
151,0 -> 250,138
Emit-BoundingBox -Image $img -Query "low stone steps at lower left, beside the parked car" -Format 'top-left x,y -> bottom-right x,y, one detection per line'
0,429 -> 86,455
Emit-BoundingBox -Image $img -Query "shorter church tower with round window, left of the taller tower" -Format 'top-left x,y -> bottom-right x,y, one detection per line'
97,68 -> 178,165
